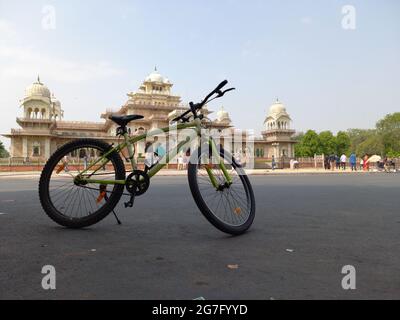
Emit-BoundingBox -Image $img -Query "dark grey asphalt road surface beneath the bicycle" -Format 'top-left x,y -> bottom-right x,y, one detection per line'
0,174 -> 400,299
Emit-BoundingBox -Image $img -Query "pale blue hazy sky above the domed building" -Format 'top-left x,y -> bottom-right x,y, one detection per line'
0,0 -> 400,146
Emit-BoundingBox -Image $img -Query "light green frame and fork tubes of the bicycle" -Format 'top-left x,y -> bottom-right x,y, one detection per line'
75,119 -> 232,188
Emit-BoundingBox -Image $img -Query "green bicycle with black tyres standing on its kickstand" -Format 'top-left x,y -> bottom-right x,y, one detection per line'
39,80 -> 255,235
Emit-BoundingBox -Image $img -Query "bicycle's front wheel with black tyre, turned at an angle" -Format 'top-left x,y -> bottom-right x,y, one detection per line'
188,148 -> 256,235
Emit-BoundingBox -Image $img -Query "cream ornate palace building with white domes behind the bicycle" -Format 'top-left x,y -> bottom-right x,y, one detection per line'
3,70 -> 295,161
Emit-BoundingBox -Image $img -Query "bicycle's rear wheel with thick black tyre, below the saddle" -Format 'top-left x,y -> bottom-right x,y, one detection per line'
39,139 -> 125,228
